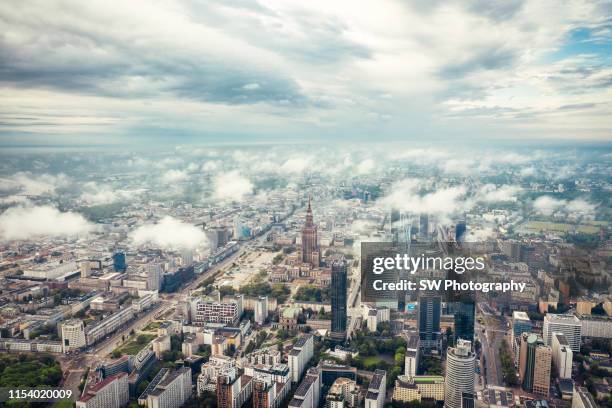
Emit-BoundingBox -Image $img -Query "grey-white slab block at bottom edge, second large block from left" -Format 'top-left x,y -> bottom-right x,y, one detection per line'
147,367 -> 192,408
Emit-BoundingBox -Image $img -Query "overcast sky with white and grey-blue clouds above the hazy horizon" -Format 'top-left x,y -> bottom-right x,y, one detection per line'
0,0 -> 612,146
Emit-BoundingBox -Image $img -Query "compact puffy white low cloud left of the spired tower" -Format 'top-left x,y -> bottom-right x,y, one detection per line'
129,216 -> 208,249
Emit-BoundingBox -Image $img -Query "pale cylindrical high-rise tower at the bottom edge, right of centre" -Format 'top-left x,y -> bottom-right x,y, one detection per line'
444,339 -> 476,408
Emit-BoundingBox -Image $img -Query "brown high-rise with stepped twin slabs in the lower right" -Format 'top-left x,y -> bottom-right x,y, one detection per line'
520,333 -> 552,397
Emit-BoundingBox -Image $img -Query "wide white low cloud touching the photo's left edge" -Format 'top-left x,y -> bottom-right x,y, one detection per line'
0,206 -> 94,241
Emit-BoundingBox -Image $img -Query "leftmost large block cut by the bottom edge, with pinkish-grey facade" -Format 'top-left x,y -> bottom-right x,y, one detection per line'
76,373 -> 130,408
